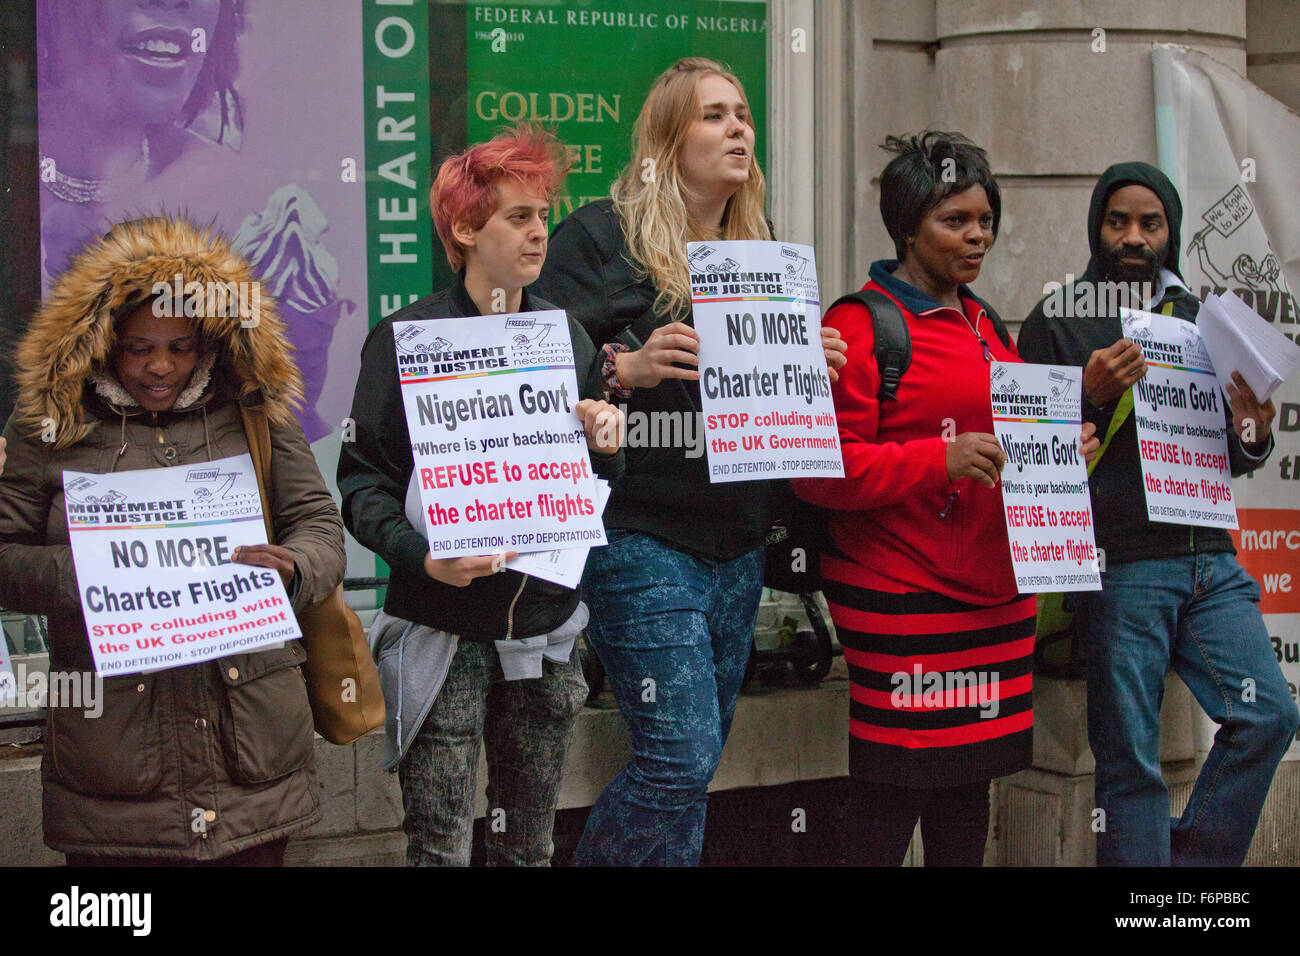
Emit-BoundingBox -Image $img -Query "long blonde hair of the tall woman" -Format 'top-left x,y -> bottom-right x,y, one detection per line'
610,56 -> 772,317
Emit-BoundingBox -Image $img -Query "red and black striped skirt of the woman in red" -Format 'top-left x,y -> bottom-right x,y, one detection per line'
823,579 -> 1036,788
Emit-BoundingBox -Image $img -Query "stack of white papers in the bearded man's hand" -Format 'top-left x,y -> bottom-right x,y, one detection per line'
1196,293 -> 1300,402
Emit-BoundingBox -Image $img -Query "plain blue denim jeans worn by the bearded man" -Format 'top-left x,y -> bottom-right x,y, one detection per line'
1084,554 -> 1300,866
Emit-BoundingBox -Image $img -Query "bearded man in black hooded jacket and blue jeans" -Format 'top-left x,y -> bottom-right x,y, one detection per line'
1018,163 -> 1300,866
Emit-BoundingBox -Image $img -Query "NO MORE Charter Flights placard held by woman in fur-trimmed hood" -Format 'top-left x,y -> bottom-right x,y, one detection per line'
64,455 -> 302,674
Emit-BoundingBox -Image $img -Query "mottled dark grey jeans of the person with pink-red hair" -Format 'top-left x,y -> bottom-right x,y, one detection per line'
398,640 -> 586,866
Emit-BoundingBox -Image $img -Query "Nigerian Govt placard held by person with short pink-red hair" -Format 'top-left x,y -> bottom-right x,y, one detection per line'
393,310 -> 606,558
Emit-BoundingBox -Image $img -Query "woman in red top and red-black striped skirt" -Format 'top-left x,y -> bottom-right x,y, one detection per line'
794,131 -> 1097,866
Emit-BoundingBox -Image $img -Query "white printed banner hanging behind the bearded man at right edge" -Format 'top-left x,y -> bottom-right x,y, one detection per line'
1153,44 -> 1300,760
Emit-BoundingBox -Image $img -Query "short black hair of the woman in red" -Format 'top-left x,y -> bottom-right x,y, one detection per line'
880,130 -> 1002,261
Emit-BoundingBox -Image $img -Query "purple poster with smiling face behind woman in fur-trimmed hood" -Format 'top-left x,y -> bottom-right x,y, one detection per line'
36,0 -> 368,447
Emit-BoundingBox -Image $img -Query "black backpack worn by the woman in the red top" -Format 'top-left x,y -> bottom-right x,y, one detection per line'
763,289 -> 1011,594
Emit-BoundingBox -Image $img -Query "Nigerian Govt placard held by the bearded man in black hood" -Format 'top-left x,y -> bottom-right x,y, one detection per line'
1121,308 -> 1236,528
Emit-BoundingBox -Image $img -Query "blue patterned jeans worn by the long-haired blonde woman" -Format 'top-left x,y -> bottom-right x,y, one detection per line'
573,529 -> 763,866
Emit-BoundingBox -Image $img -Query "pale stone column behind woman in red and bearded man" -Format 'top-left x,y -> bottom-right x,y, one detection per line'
933,0 -> 1245,326
